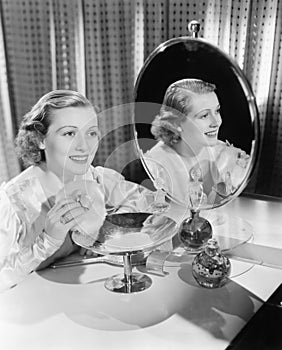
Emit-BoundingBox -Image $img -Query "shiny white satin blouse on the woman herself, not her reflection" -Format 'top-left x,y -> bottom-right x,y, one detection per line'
0,166 -> 148,291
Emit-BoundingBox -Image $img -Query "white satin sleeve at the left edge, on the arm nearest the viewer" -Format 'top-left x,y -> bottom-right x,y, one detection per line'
0,189 -> 63,291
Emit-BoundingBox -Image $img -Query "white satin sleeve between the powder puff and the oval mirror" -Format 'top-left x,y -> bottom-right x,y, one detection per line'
96,167 -> 154,213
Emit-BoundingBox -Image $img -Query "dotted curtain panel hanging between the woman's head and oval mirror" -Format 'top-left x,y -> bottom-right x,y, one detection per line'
83,0 -> 143,172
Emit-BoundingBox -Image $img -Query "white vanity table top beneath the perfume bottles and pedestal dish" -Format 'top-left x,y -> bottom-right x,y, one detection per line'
0,197 -> 282,350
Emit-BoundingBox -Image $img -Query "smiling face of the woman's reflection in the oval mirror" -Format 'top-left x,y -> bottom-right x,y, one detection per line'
181,92 -> 222,150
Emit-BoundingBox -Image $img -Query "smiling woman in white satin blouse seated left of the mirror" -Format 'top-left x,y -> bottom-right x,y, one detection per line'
0,90 -> 150,290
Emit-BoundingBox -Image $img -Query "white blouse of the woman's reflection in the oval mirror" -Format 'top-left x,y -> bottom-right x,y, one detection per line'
144,141 -> 249,203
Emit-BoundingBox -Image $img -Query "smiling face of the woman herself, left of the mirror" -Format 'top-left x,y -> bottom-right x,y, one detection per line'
43,107 -> 99,182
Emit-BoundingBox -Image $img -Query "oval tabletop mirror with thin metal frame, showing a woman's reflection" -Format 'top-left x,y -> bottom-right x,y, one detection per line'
134,37 -> 259,210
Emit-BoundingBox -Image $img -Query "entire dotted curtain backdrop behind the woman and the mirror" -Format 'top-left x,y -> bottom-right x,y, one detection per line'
0,0 -> 282,196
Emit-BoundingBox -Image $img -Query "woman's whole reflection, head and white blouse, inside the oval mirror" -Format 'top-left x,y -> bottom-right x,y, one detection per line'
145,79 -> 249,204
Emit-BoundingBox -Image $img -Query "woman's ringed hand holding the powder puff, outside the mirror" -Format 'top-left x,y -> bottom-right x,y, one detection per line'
44,197 -> 86,240
